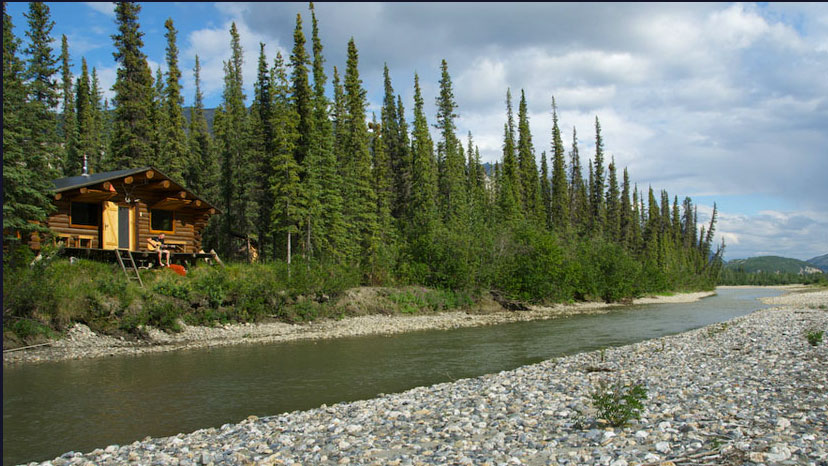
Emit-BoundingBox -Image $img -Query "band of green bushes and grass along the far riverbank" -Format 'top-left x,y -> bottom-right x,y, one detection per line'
3,227 -> 718,349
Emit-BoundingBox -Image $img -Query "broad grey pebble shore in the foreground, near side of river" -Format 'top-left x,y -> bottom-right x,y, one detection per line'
27,291 -> 828,466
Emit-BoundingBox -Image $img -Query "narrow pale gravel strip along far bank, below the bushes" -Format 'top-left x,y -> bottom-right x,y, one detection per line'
3,292 -> 715,365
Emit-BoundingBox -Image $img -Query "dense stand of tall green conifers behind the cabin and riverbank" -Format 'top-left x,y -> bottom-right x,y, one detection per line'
3,2 -> 724,302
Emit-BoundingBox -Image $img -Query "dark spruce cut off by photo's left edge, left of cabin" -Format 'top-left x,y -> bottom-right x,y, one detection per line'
3,6 -> 54,240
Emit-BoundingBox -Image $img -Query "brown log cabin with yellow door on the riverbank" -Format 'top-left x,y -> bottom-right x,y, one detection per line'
30,167 -> 218,264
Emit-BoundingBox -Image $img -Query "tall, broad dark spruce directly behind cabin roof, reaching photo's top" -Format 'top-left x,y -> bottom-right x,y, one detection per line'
108,2 -> 154,170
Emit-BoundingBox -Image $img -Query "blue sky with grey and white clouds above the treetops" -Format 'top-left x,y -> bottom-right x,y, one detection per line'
7,3 -> 828,260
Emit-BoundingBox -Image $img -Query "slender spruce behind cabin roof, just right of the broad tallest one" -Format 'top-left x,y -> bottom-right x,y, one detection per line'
158,18 -> 191,185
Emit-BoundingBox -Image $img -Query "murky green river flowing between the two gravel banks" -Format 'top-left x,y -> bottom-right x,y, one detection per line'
3,288 -> 780,465
